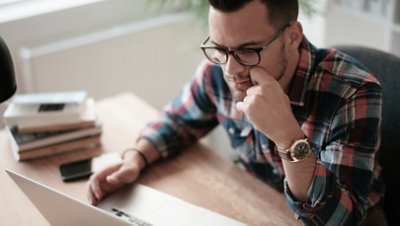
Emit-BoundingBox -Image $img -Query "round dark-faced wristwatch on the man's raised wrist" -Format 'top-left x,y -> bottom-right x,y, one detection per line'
277,138 -> 311,162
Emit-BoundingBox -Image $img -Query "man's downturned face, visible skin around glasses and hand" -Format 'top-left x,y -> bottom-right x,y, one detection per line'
209,1 -> 287,101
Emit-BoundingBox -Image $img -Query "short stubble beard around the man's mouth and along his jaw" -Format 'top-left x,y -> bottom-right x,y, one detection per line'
224,42 -> 288,102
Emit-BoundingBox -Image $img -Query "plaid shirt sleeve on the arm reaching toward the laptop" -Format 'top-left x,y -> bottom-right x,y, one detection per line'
139,62 -> 218,158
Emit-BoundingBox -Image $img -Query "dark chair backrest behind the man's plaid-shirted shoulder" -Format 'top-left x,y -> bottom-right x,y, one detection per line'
335,46 -> 400,225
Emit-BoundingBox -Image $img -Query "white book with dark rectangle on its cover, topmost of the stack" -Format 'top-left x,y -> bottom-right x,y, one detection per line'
3,92 -> 88,126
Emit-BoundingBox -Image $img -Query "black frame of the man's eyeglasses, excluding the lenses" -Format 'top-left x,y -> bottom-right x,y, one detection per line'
200,23 -> 291,66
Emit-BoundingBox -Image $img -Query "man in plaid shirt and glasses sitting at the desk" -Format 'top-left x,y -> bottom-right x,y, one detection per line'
88,0 -> 382,225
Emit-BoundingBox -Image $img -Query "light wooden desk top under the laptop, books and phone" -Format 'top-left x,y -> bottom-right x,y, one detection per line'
0,93 -> 300,226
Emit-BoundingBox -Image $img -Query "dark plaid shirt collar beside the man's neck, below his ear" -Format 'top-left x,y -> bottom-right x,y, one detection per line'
288,36 -> 317,106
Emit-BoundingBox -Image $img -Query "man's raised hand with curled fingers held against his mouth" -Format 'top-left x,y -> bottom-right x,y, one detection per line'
236,67 -> 304,149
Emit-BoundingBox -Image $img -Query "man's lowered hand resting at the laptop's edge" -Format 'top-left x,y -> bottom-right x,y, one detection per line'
87,159 -> 140,205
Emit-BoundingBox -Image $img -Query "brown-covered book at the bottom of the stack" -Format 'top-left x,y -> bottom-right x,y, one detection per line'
11,135 -> 101,161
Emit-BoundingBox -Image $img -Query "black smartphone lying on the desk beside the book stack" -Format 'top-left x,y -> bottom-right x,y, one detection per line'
60,158 -> 93,181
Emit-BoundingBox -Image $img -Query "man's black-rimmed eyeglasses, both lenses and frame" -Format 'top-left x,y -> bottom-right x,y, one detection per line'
200,24 -> 290,66
